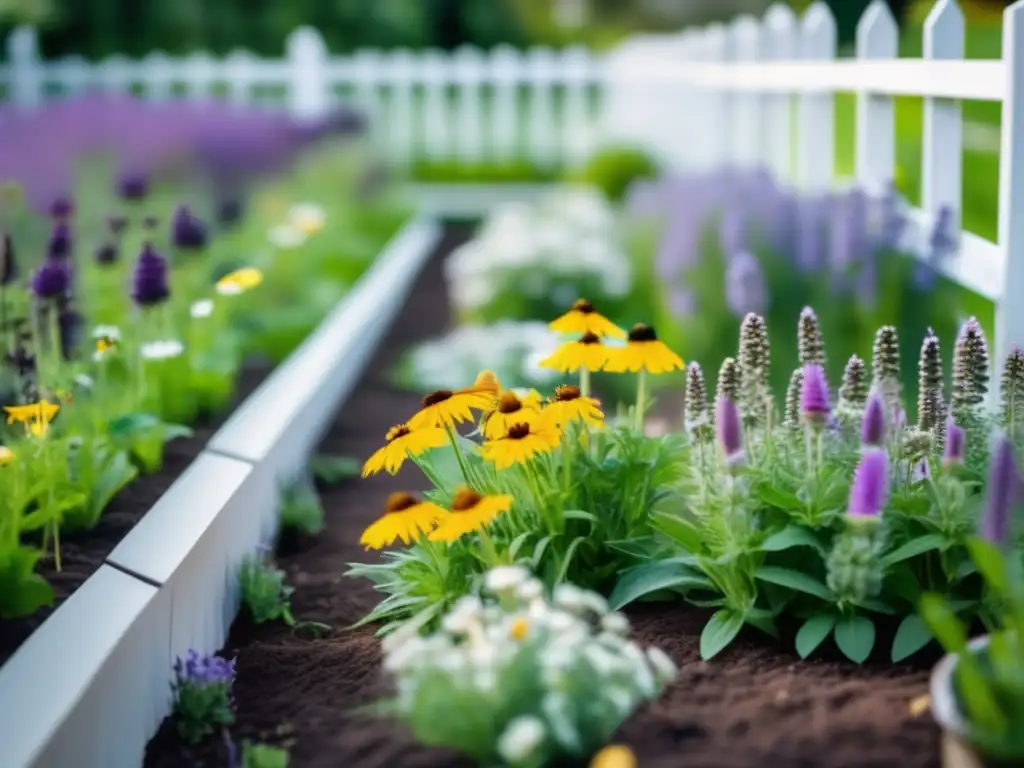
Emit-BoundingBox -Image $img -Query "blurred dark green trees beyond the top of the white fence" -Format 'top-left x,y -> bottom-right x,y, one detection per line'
0,0 -> 1010,58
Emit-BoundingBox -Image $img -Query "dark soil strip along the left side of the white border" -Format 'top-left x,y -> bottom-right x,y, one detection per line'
0,362 -> 271,666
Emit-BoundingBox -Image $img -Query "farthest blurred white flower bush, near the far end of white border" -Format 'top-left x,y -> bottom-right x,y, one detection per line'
444,186 -> 633,309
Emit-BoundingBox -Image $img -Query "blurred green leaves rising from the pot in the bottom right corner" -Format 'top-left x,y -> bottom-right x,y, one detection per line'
921,539 -> 1024,765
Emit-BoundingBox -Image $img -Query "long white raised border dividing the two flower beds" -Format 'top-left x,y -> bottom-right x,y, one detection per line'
0,217 -> 441,768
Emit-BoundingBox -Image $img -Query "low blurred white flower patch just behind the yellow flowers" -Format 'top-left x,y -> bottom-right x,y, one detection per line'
407,321 -> 562,389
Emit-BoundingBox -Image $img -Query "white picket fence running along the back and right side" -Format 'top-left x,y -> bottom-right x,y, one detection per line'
0,0 -> 1024,370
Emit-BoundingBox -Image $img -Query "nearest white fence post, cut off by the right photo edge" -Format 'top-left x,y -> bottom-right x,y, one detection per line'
993,0 -> 1024,372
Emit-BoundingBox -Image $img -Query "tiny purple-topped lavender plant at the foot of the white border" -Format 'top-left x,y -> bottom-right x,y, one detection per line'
173,650 -> 234,744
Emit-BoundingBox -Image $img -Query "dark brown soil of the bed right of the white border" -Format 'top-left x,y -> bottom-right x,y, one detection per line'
145,225 -> 938,768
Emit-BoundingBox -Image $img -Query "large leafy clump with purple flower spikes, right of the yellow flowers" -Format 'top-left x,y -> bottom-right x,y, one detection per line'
610,312 -> 1020,662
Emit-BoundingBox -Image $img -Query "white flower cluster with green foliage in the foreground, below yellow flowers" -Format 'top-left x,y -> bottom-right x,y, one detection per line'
384,566 -> 677,767
